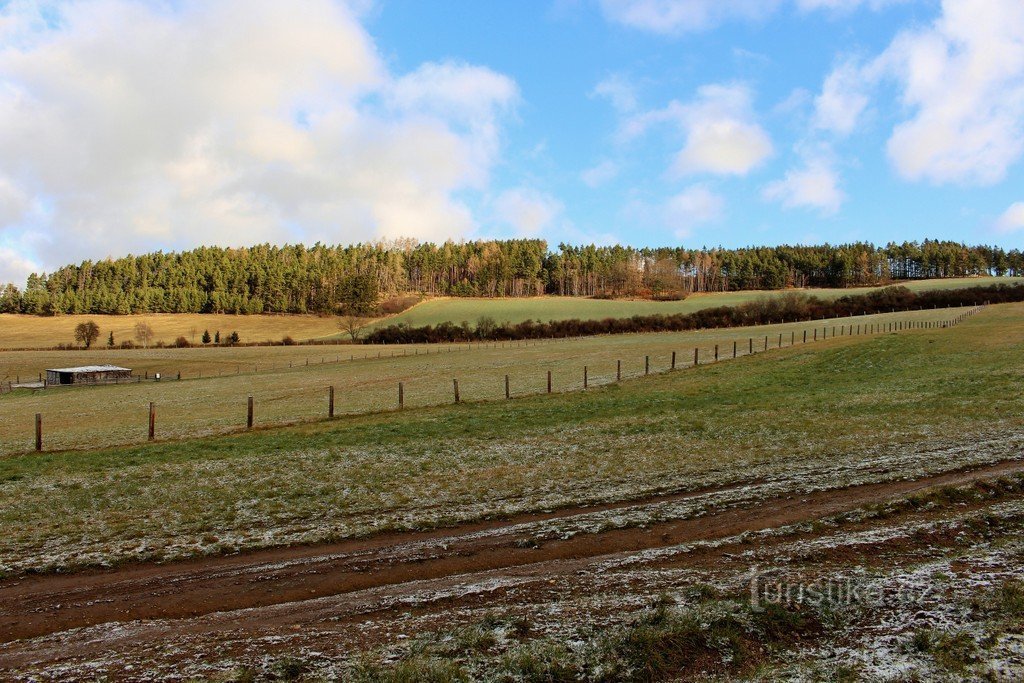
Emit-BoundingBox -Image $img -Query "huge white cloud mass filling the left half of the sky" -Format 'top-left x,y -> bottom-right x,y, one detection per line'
0,0 -> 518,279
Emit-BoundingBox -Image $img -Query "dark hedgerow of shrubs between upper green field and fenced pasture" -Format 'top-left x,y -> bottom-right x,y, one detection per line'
365,284 -> 1024,344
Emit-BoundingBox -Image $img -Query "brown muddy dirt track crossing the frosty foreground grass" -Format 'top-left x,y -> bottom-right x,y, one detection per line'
0,460 -> 1024,643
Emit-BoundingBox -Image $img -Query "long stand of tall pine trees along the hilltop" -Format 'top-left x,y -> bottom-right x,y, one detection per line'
0,240 -> 1024,315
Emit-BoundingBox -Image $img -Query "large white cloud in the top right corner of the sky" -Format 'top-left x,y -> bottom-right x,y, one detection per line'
871,0 -> 1024,185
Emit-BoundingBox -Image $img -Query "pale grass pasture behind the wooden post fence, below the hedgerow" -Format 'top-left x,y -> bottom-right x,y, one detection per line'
0,309 -> 958,455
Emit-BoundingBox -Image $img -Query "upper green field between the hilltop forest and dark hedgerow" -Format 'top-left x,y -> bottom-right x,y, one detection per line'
372,278 -> 1024,327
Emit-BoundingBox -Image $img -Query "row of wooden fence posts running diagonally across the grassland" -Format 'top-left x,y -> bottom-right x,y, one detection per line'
24,306 -> 984,452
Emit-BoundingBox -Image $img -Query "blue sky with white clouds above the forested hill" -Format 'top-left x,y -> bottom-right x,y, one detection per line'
0,0 -> 1024,285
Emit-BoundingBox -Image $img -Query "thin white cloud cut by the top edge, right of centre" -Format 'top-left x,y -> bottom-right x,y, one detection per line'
601,0 -> 780,35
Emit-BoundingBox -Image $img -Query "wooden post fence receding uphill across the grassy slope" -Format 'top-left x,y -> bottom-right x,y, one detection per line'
22,306 -> 983,452
